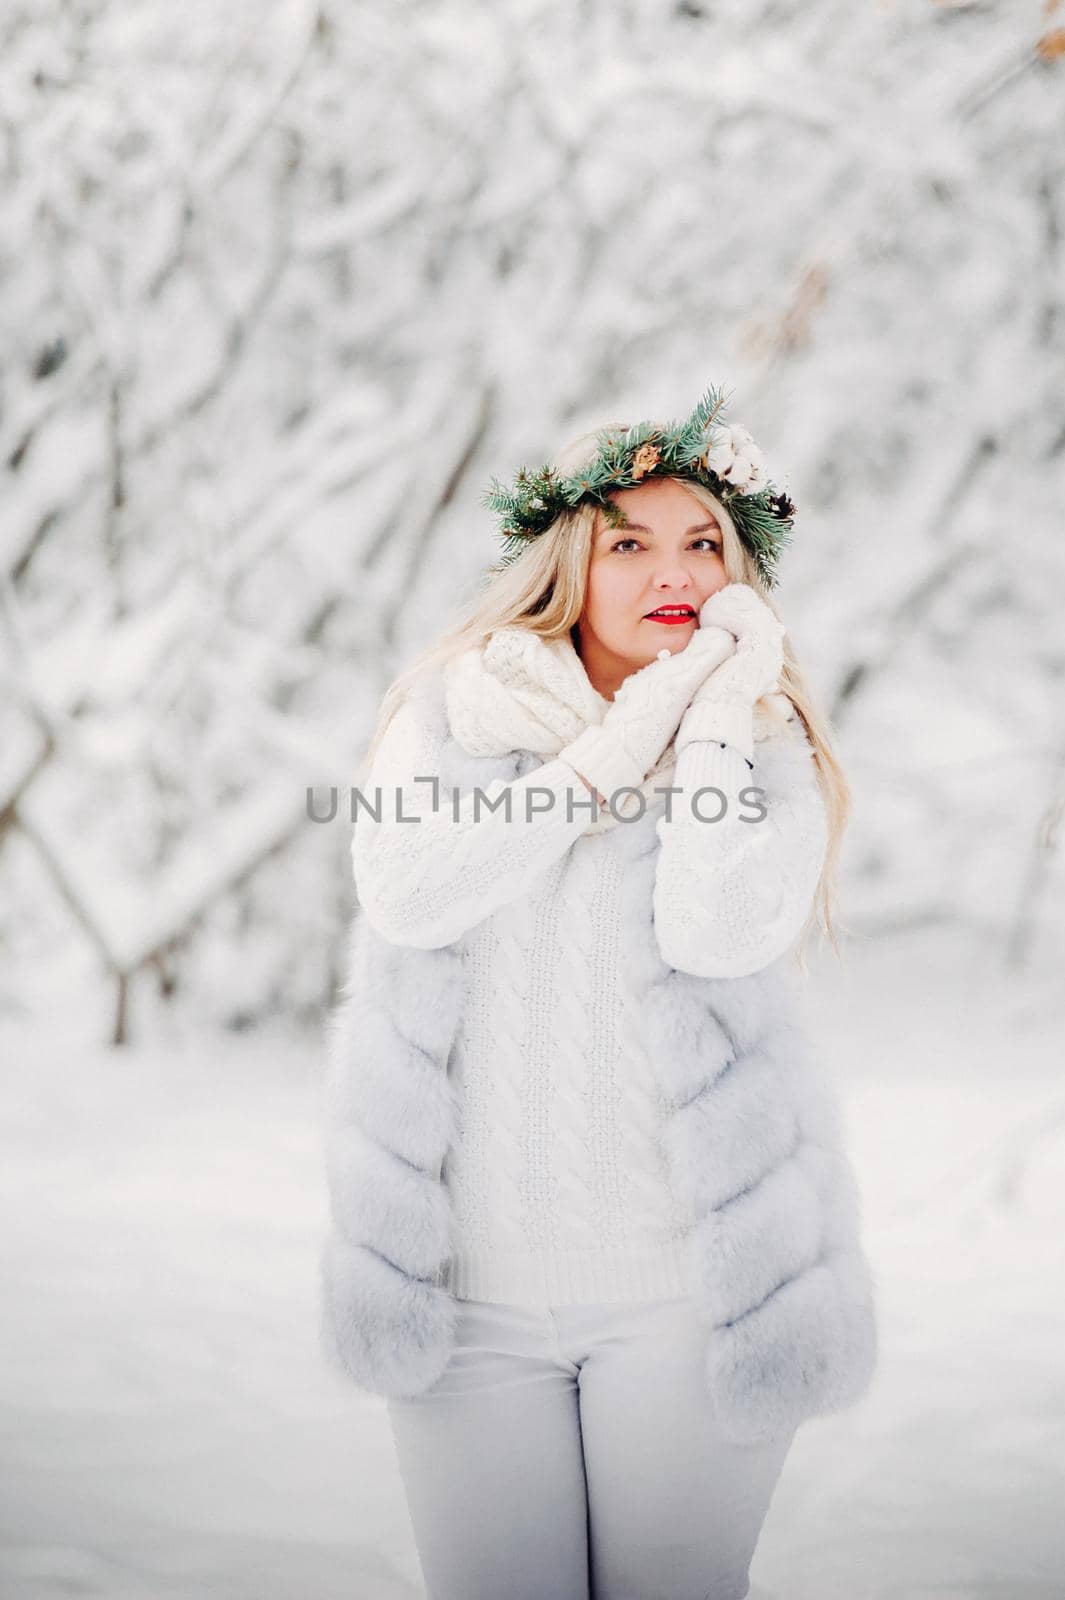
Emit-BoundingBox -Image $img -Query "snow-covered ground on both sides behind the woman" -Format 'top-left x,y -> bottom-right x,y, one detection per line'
0,931 -> 1065,1600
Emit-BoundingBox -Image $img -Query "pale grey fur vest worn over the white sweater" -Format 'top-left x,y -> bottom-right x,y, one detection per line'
320,675 -> 876,1442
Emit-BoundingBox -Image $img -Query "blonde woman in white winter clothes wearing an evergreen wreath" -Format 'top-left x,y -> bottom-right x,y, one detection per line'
323,390 -> 875,1600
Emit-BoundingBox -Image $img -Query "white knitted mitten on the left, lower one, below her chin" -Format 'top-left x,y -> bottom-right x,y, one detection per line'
558,627 -> 736,798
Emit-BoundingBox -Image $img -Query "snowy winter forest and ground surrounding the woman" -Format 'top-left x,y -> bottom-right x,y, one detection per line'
0,0 -> 1065,1600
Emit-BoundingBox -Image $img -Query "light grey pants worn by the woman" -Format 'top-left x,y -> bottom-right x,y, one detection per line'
387,1299 -> 793,1600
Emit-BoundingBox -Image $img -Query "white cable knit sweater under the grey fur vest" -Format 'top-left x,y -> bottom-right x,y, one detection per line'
352,646 -> 825,1304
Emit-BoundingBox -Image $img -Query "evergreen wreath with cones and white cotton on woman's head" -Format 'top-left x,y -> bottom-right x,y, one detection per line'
481,387 -> 795,589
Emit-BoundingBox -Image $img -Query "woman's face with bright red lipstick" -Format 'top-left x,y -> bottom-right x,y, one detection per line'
576,478 -> 729,699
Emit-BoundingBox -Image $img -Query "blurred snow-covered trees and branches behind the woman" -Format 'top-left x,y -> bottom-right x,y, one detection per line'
0,0 -> 1065,1037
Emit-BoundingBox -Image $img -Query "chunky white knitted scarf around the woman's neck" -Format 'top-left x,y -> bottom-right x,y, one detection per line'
445,624 -> 793,834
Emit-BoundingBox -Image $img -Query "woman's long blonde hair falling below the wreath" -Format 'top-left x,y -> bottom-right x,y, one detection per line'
363,422 -> 851,968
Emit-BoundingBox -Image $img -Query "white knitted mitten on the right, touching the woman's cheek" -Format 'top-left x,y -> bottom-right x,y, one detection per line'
676,584 -> 787,762
